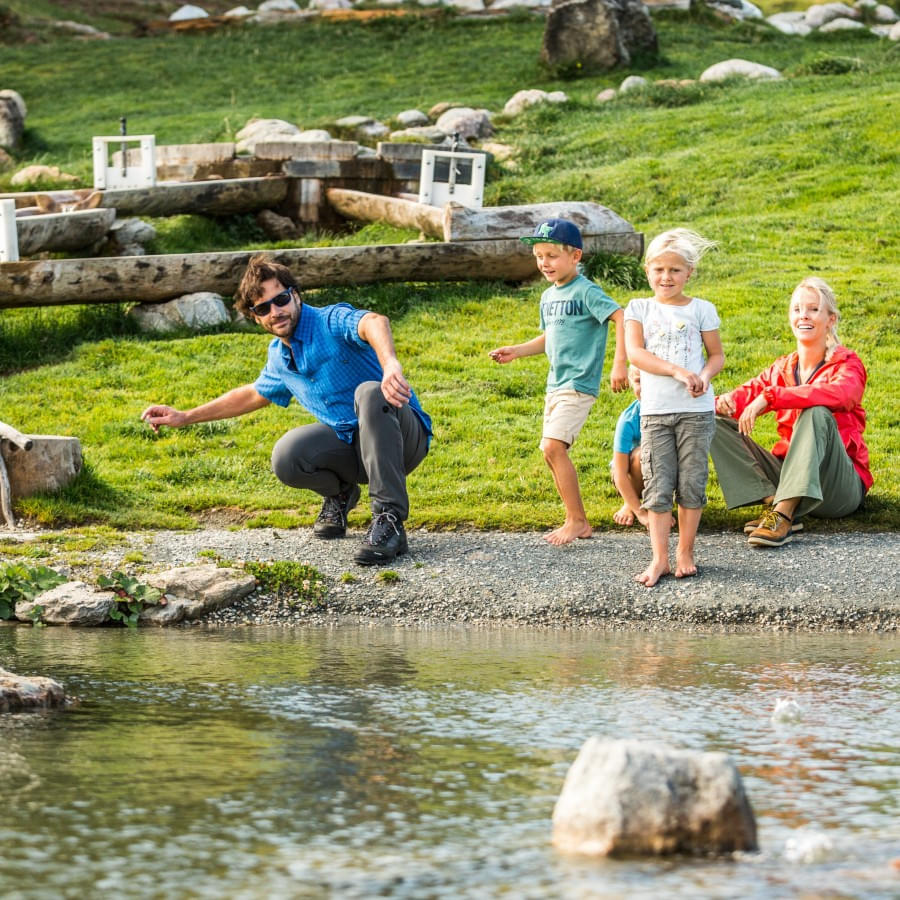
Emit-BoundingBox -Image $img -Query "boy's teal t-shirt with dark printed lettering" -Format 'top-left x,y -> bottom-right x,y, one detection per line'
541,275 -> 621,397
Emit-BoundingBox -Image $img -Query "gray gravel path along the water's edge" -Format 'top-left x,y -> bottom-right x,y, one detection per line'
22,529 -> 900,633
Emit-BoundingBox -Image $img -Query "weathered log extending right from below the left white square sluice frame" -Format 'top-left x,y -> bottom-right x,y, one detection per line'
103,176 -> 288,216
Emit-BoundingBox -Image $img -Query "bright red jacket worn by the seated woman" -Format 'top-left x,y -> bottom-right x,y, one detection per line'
731,346 -> 872,490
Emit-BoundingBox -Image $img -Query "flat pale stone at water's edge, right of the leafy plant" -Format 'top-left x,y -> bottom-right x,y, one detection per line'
139,565 -> 256,625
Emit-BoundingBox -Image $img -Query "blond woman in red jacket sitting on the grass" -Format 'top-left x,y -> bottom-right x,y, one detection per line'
710,278 -> 872,547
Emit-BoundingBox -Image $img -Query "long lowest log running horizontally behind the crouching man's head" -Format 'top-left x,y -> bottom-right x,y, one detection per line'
0,231 -> 644,309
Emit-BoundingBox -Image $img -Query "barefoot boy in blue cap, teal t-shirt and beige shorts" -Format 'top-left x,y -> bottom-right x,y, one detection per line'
490,219 -> 628,546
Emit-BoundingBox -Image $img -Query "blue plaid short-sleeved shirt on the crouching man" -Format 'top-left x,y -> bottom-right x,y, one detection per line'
254,303 -> 432,444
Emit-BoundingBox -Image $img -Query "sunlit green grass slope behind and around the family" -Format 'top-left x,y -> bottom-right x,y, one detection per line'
0,17 -> 900,529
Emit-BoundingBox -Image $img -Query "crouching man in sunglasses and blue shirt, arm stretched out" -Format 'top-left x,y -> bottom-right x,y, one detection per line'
141,255 -> 432,565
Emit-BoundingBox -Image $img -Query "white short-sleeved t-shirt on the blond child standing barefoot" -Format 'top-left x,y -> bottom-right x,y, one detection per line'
625,297 -> 720,416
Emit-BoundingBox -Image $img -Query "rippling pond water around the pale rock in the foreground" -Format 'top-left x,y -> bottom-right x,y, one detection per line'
0,626 -> 900,900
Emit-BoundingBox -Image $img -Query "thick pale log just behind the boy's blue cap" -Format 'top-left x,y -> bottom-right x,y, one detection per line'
444,201 -> 634,241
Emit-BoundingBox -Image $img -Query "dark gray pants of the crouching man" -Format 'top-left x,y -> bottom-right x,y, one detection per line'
272,381 -> 428,521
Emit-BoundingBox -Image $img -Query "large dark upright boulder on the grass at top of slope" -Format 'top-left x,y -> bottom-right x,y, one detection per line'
541,0 -> 659,72
